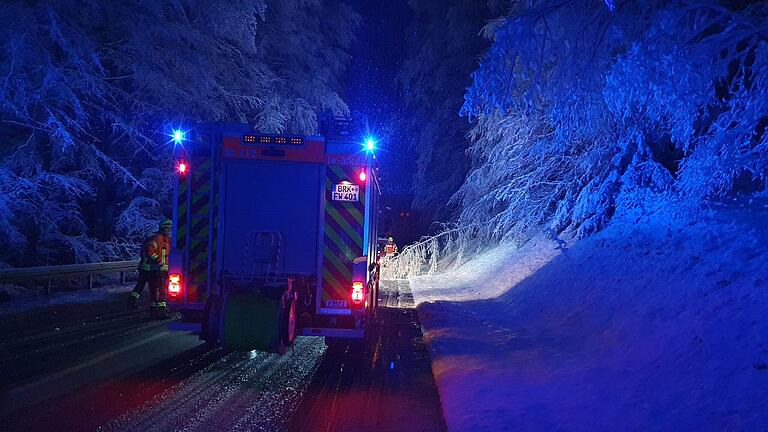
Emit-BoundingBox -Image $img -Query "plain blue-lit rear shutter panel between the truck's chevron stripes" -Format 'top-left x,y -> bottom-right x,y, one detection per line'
221,159 -> 322,277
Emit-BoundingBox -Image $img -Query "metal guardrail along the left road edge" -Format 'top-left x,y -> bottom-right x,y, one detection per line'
0,260 -> 139,294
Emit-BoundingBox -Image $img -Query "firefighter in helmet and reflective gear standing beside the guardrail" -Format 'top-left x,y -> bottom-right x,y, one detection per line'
131,219 -> 173,318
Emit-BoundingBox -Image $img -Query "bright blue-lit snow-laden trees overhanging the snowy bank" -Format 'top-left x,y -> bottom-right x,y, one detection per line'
454,0 -> 768,238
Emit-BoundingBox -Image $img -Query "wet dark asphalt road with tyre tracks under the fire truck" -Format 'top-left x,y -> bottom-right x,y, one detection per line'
0,282 -> 445,432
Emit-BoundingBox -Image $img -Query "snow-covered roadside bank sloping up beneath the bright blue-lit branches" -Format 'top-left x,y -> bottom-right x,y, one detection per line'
411,209 -> 768,432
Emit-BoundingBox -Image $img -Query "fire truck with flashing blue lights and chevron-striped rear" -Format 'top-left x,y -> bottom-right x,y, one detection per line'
167,119 -> 380,353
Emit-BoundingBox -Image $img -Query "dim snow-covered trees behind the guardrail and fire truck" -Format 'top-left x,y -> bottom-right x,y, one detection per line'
0,0 -> 359,265
